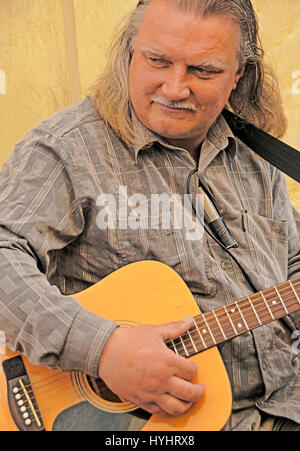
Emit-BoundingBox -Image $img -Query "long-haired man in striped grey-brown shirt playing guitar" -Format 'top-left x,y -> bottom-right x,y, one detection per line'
0,0 -> 300,430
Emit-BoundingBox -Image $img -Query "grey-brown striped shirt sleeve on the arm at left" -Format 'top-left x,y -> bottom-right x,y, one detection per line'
0,129 -> 117,377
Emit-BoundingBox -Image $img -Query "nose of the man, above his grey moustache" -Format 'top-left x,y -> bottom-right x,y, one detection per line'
162,69 -> 191,100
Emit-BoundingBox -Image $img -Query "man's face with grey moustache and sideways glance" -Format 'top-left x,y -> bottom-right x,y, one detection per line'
129,0 -> 242,150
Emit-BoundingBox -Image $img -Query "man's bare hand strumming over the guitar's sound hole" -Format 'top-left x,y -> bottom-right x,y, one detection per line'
99,318 -> 204,415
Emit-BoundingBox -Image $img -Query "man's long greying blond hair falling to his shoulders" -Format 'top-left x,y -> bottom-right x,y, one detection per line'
89,0 -> 286,146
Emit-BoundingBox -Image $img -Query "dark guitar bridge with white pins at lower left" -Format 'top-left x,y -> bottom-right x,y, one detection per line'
2,356 -> 45,431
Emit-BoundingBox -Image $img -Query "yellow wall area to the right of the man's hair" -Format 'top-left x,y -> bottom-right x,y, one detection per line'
253,0 -> 300,211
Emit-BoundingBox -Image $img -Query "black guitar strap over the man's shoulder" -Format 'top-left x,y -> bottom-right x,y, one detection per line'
222,109 -> 300,183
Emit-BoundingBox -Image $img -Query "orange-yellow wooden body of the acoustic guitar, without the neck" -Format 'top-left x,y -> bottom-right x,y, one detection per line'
0,261 -> 232,431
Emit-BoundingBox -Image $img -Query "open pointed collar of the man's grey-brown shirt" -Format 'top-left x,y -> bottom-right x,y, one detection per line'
132,111 -> 237,161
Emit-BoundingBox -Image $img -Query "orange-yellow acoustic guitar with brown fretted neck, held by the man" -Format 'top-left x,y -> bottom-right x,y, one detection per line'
0,261 -> 300,431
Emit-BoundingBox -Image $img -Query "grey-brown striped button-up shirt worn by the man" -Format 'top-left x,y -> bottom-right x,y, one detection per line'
0,99 -> 300,430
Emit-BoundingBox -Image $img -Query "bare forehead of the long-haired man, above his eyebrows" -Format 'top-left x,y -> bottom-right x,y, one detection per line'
135,0 -> 241,63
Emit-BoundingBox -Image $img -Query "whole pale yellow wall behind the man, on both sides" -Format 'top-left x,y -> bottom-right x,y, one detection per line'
0,0 -> 300,210
